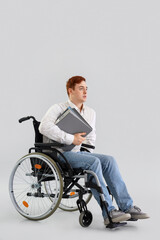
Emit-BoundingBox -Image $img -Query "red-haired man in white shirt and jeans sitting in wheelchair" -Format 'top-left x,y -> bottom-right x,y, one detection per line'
39,76 -> 149,225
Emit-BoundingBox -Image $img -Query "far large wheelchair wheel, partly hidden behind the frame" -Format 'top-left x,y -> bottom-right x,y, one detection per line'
59,178 -> 92,212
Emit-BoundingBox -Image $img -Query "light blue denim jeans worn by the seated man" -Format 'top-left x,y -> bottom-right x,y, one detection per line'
58,151 -> 133,219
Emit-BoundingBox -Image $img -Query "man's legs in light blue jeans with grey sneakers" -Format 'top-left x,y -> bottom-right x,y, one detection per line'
58,152 -> 149,221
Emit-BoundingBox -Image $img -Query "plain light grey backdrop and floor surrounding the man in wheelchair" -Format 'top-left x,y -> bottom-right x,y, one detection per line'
0,0 -> 160,240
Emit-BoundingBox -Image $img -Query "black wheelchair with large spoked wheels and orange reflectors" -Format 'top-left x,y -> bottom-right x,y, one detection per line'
9,116 -> 126,228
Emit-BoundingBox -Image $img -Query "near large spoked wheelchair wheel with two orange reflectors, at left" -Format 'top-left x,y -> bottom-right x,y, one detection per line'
9,153 -> 63,220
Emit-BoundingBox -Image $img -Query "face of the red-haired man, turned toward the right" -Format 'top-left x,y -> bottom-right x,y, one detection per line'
70,81 -> 88,103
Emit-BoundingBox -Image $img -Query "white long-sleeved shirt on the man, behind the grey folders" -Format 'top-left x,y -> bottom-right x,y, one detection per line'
39,100 -> 96,152
